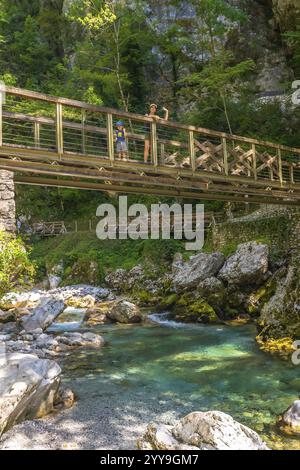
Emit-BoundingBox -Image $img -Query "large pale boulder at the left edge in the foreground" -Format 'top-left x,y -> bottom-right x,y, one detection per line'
0,353 -> 61,435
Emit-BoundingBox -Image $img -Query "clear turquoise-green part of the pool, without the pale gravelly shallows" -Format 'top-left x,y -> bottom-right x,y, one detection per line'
60,317 -> 300,449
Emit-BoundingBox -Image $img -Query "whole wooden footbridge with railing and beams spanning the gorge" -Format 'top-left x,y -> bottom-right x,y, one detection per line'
0,87 -> 300,205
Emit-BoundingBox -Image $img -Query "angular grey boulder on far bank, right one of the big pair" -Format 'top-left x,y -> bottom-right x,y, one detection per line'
219,242 -> 269,286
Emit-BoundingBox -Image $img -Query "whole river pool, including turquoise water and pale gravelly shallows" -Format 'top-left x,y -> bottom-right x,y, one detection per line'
45,314 -> 300,449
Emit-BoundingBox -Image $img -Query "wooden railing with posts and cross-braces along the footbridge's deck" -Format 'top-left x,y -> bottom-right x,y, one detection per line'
0,87 -> 300,187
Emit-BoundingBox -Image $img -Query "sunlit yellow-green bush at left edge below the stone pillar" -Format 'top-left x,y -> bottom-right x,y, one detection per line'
0,232 -> 35,296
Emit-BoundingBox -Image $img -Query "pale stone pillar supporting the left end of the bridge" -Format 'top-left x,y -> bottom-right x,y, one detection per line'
0,170 -> 16,232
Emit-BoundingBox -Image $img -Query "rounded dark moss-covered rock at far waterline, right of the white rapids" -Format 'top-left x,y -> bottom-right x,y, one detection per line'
174,293 -> 219,323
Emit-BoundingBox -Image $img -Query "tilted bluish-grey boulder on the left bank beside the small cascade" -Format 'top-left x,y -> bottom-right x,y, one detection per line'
20,297 -> 65,331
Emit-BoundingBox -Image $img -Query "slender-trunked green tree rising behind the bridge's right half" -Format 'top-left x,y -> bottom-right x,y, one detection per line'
178,0 -> 255,133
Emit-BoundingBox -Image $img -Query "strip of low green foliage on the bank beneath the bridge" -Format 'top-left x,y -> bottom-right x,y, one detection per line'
31,232 -> 185,282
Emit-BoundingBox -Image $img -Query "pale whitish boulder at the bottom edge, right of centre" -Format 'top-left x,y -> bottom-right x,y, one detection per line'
137,411 -> 268,450
